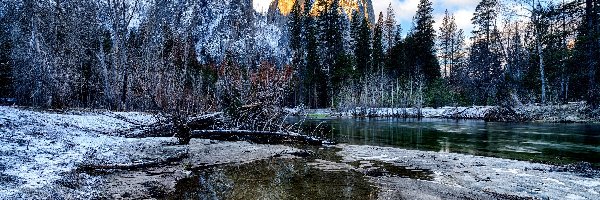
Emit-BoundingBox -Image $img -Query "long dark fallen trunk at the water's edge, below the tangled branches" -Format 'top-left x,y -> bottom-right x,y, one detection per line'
191,130 -> 335,145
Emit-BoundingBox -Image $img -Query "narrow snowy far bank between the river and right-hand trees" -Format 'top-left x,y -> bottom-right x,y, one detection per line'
296,102 -> 600,123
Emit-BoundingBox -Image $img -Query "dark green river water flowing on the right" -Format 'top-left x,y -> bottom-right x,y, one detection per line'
303,119 -> 600,167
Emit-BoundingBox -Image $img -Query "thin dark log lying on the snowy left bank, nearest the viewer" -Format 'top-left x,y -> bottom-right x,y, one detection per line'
77,153 -> 188,171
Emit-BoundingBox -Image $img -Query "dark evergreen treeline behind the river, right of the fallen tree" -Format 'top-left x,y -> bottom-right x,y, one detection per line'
289,0 -> 599,108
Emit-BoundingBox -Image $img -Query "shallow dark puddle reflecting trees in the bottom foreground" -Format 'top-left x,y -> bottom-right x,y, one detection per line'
171,159 -> 376,199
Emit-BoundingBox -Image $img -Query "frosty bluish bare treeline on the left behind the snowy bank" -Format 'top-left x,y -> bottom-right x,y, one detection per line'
0,0 -> 272,112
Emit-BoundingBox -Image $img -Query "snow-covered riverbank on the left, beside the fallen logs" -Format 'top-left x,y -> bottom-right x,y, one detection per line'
0,106 -> 294,199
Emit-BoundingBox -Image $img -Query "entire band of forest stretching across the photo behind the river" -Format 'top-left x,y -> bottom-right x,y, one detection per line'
0,0 -> 600,111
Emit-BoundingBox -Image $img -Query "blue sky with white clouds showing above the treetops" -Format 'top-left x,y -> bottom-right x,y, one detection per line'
254,0 -> 479,35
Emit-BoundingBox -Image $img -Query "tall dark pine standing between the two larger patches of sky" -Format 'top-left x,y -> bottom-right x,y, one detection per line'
411,0 -> 441,82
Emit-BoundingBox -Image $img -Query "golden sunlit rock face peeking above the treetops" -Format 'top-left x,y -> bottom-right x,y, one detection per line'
269,0 -> 375,23
